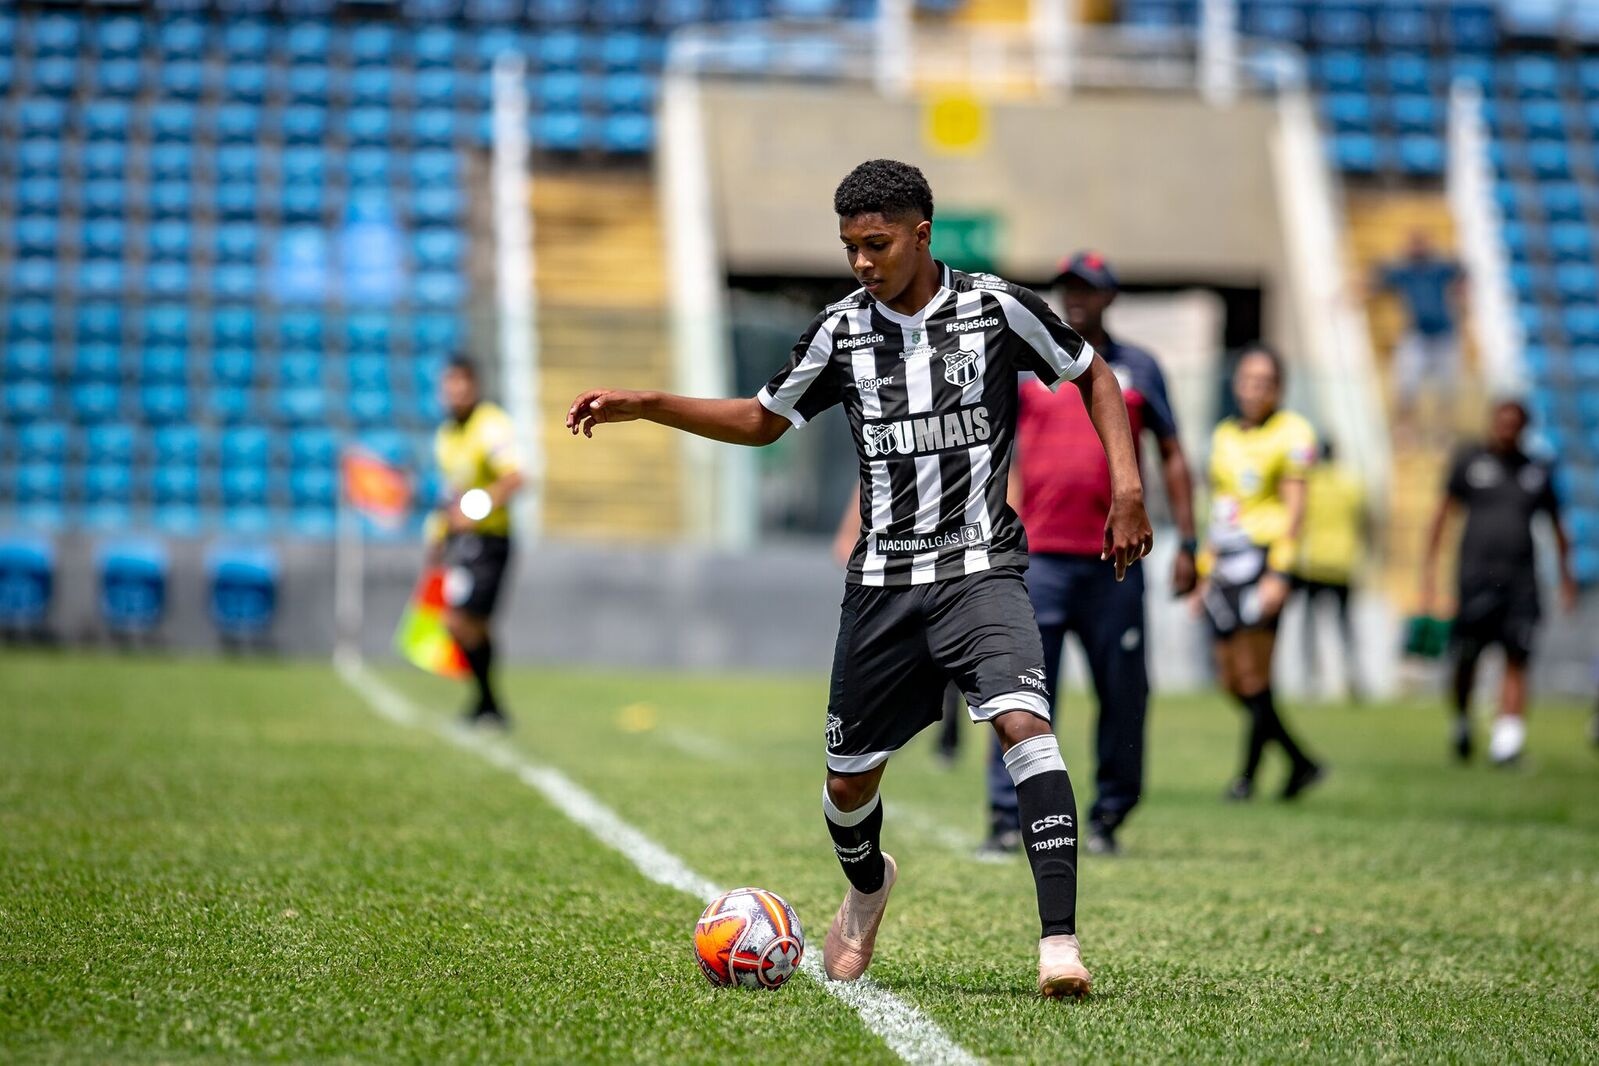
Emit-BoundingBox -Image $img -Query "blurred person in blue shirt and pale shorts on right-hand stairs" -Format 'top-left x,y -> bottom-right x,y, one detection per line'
1377,230 -> 1463,432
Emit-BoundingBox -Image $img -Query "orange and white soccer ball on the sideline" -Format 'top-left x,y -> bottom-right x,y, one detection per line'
694,889 -> 804,988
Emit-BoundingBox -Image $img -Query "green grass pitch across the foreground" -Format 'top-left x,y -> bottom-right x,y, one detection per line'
0,652 -> 1599,1063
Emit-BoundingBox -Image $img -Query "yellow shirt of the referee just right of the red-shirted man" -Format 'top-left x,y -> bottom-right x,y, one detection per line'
1206,411 -> 1316,574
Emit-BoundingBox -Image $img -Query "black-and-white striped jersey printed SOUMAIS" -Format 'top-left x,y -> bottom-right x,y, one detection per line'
760,264 -> 1094,587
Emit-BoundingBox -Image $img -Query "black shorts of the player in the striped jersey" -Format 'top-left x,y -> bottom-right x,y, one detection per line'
827,567 -> 1049,774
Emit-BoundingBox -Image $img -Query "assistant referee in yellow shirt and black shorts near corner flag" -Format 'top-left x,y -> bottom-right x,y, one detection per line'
427,356 -> 523,729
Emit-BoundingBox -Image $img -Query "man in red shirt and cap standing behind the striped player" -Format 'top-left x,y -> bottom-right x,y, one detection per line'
982,253 -> 1196,855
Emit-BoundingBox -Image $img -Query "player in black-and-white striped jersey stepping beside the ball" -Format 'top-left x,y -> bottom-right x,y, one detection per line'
566,160 -> 1153,997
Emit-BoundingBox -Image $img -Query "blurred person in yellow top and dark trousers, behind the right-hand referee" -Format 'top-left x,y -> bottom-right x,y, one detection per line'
1294,441 -> 1370,702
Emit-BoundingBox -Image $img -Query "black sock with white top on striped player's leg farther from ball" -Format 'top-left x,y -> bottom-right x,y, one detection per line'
1004,734 -> 1078,937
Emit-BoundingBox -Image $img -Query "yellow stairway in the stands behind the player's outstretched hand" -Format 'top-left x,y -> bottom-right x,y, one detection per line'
532,171 -> 683,540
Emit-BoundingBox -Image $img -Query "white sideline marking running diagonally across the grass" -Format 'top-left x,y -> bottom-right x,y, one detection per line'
334,657 -> 982,1066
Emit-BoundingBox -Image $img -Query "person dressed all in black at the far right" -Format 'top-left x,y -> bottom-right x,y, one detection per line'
1422,400 -> 1577,766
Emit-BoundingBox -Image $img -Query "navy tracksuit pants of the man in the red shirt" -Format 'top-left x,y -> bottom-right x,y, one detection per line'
988,551 -> 1150,828
